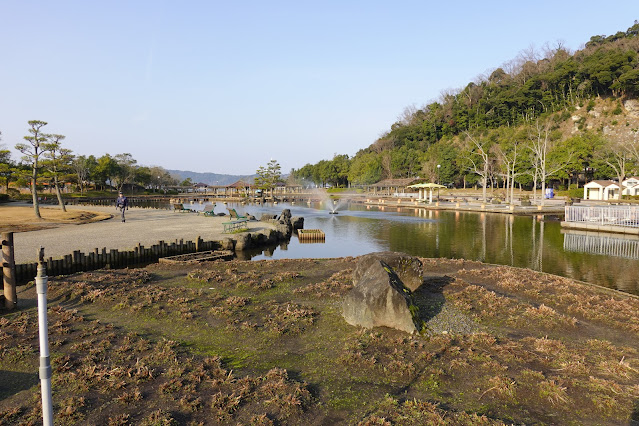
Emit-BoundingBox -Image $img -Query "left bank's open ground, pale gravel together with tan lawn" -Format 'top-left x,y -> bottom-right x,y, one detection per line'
0,205 -> 271,263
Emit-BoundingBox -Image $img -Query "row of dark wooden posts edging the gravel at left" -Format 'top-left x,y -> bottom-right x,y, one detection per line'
2,232 -> 220,308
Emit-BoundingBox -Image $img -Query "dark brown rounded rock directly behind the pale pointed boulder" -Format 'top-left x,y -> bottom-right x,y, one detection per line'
353,251 -> 424,291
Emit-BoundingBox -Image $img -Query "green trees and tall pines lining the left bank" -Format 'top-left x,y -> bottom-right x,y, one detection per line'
0,120 -> 185,217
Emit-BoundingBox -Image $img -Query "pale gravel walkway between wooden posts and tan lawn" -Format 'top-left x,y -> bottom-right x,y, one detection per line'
13,206 -> 271,263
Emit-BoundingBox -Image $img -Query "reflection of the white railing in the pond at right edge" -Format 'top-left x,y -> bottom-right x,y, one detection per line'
564,232 -> 639,259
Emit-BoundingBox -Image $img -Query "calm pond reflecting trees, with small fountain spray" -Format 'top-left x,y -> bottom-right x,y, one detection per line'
104,202 -> 639,295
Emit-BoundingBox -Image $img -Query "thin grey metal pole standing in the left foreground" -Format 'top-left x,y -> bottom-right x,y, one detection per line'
36,247 -> 53,426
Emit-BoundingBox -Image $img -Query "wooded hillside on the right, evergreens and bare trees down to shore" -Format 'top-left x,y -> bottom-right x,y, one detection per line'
292,21 -> 639,195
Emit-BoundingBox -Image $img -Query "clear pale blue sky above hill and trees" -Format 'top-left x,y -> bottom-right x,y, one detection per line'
0,0 -> 639,174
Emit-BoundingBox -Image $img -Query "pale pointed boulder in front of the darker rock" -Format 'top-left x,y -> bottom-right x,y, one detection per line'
342,260 -> 422,333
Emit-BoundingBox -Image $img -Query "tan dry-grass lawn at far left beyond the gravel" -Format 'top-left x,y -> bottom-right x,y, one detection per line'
0,204 -> 112,232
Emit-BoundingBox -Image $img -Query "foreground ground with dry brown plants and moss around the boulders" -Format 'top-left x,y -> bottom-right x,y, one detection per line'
0,258 -> 639,426
